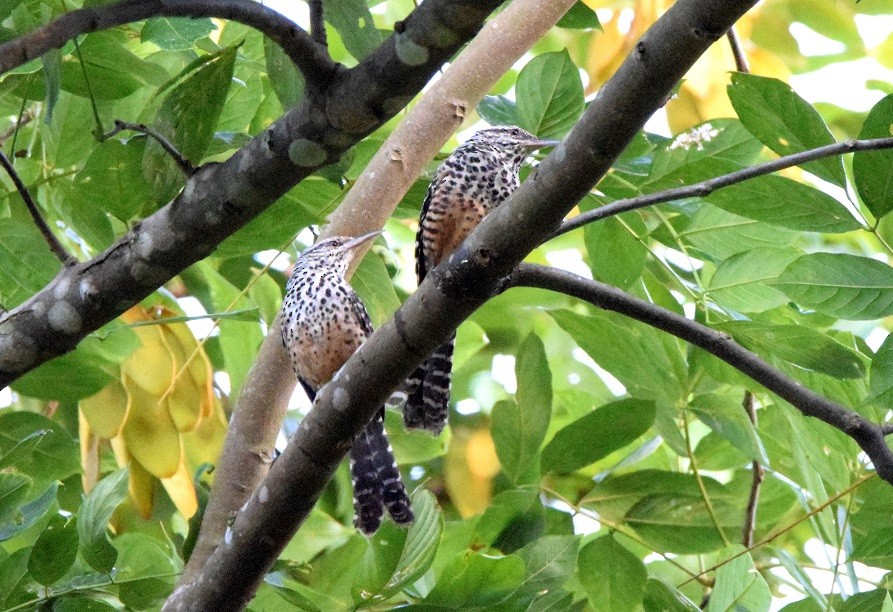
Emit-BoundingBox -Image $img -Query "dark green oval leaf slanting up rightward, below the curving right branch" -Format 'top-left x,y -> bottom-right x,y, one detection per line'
542,398 -> 655,473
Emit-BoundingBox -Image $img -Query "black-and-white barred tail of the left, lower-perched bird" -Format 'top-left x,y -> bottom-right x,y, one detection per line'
350,411 -> 415,534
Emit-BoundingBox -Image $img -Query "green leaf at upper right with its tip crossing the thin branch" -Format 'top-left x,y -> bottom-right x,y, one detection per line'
728,72 -> 846,187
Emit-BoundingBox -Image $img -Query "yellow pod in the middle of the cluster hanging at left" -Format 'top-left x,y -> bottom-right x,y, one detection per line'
121,375 -> 182,478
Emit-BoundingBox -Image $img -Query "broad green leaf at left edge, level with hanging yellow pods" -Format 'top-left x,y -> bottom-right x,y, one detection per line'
0,411 -> 80,481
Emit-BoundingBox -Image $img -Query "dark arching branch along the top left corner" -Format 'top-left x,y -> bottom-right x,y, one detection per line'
0,0 -> 337,89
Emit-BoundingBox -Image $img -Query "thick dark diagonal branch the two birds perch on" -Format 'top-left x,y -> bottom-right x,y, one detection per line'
166,0 -> 756,610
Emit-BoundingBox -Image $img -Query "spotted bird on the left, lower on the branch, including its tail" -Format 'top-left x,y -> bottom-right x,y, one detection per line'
281,231 -> 414,535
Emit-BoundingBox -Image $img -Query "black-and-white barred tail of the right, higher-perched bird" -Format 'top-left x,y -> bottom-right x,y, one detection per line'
403,333 -> 456,435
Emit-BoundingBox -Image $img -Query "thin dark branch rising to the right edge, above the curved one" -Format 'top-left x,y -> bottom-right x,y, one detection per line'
548,137 -> 893,240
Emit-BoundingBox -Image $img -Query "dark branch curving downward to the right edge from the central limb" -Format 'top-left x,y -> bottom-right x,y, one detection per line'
512,264 -> 893,484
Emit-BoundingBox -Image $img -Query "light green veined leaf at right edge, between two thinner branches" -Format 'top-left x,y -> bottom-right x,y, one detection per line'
774,253 -> 893,320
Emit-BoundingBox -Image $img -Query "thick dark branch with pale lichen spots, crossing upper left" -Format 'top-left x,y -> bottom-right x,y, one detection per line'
0,0 -> 499,387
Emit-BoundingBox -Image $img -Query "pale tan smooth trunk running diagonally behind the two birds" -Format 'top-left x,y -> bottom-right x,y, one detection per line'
180,0 -> 575,584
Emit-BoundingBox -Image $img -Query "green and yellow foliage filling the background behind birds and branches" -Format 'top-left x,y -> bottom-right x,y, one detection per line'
0,0 -> 893,610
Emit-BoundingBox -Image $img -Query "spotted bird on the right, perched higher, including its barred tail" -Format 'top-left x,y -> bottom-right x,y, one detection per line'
403,126 -> 559,435
